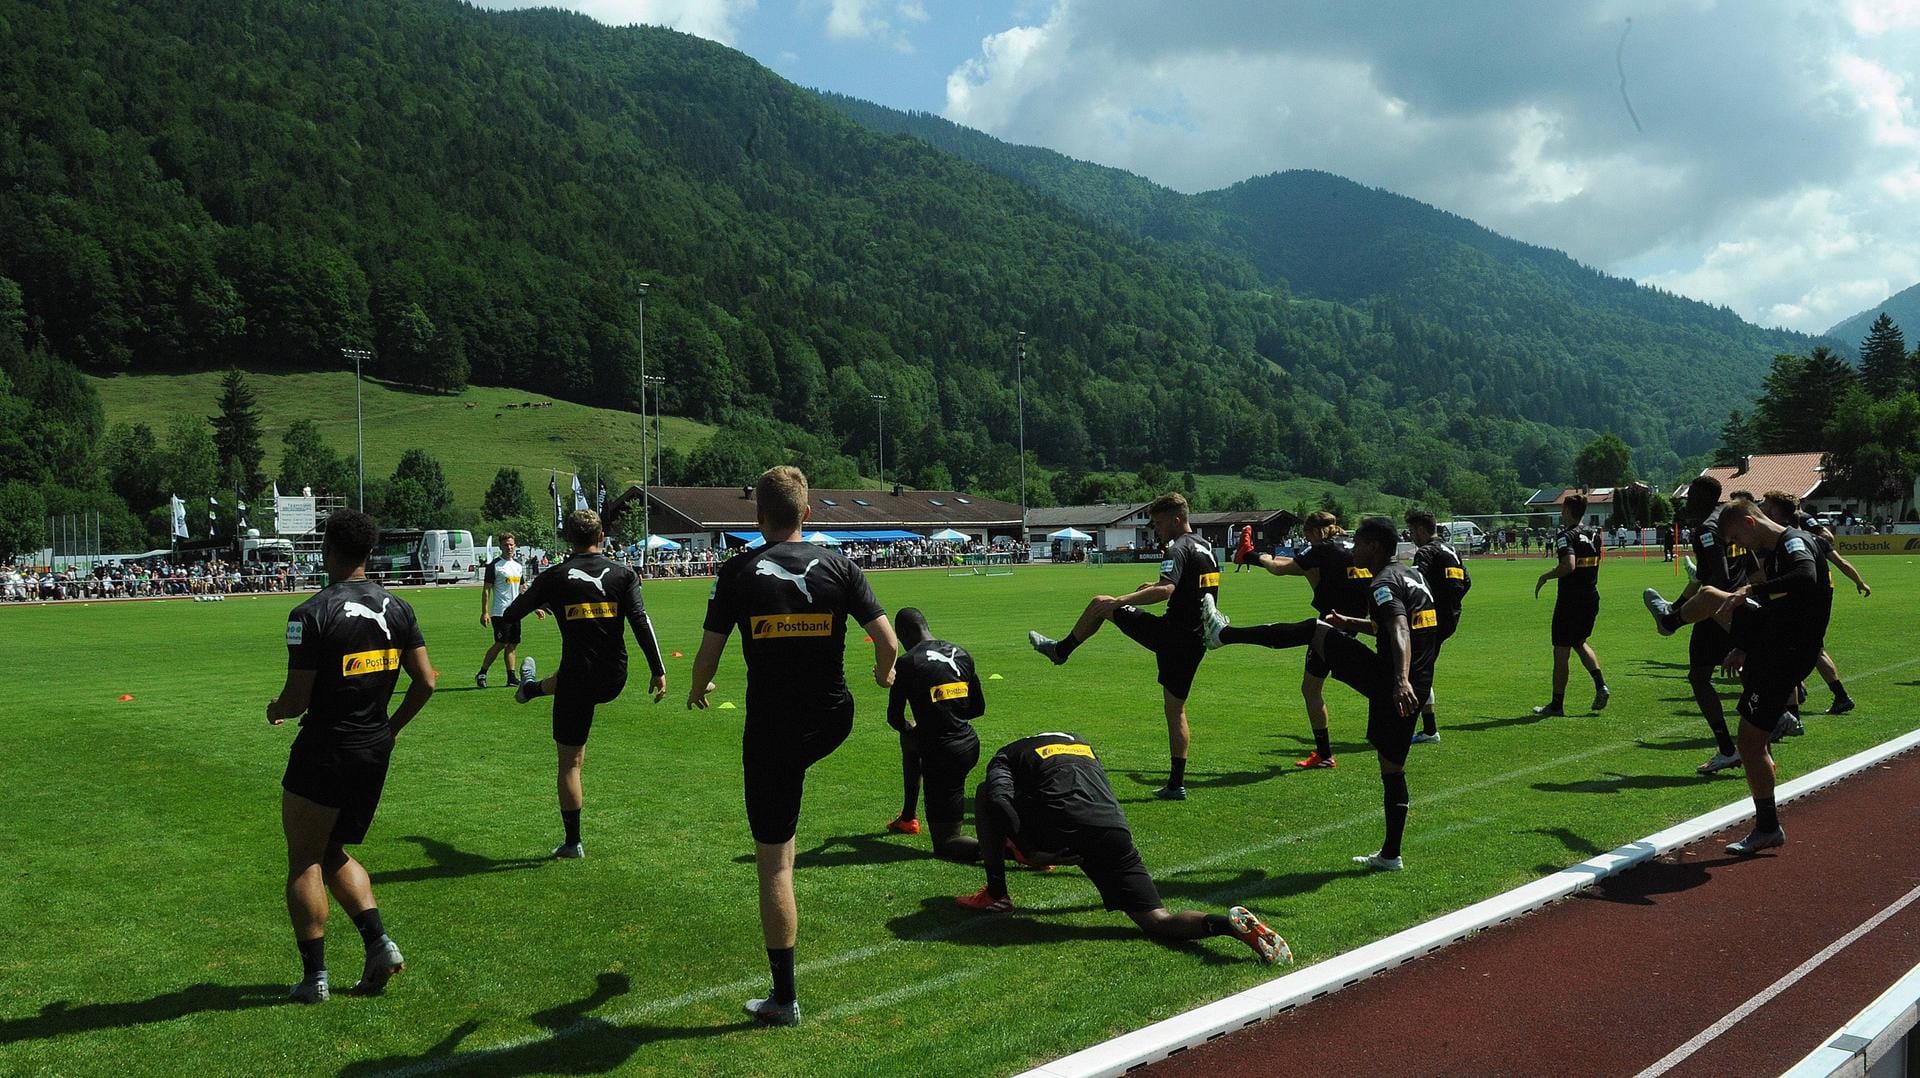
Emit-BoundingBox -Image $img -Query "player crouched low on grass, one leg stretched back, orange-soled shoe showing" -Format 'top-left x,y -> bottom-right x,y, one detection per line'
956,734 -> 1294,963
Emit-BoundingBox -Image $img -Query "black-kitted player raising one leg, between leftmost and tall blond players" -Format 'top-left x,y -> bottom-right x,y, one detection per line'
493,509 -> 666,861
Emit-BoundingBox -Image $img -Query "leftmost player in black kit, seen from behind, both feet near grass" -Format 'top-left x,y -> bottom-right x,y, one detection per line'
267,509 -> 434,1003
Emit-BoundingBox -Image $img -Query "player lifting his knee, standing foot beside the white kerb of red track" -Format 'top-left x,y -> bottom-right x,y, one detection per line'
1647,498 -> 1834,857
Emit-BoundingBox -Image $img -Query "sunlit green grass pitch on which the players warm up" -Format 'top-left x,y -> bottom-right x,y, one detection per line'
0,557 -> 1920,1076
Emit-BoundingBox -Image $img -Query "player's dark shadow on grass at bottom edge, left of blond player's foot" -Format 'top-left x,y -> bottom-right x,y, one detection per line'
340,972 -> 753,1078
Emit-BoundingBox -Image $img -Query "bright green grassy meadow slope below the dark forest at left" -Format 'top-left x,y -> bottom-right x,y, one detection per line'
94,371 -> 714,507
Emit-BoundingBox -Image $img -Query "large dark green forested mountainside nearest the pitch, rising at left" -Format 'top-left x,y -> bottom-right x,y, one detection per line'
0,0 -> 1768,538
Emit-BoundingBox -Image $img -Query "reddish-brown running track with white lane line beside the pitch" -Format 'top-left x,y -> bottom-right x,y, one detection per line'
1135,753 -> 1920,1078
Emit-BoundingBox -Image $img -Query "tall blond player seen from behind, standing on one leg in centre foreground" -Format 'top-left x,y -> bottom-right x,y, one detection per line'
687,465 -> 900,1026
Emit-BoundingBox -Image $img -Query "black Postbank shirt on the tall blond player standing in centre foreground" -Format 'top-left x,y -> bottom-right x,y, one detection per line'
707,542 -> 887,721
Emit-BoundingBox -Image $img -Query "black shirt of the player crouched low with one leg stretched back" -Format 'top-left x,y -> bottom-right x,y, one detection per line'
981,734 -> 1127,849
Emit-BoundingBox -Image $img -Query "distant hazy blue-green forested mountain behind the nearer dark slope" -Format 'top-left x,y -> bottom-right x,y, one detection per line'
824,94 -> 1827,469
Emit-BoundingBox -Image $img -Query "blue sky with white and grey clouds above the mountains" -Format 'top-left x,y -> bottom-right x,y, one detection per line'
464,0 -> 1920,332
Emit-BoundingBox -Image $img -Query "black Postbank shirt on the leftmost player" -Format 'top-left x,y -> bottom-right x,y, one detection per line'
286,580 -> 426,747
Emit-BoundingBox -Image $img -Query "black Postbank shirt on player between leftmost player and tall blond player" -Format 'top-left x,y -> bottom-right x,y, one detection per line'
499,553 -> 666,678
